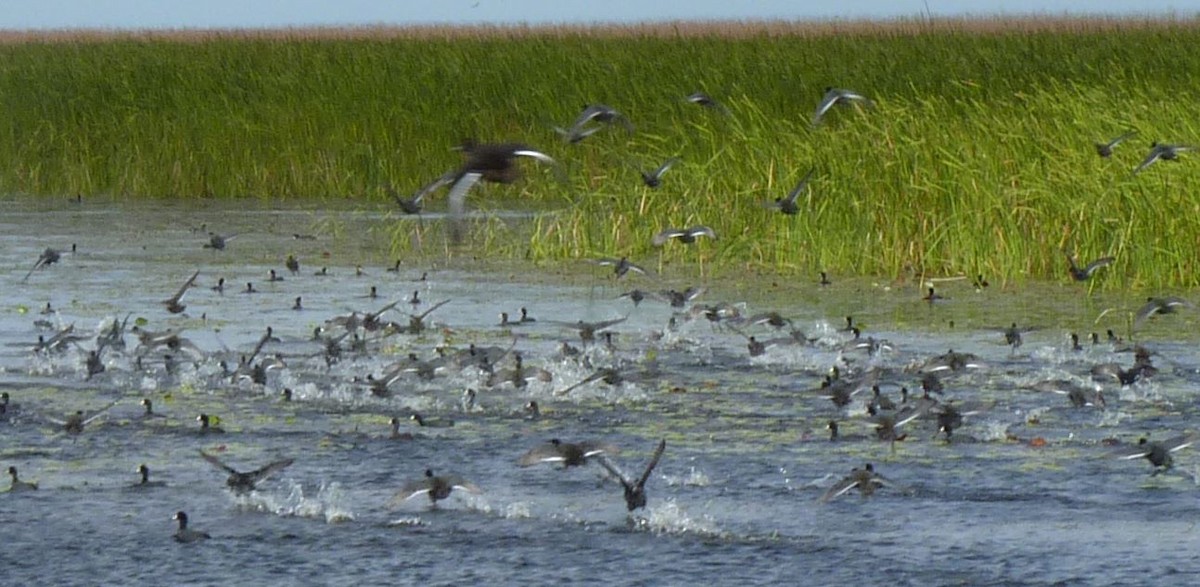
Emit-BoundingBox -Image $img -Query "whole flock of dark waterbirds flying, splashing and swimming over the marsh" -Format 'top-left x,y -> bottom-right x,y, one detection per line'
0,88 -> 1196,543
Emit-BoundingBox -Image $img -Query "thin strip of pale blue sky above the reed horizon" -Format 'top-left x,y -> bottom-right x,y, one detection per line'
0,0 -> 1200,30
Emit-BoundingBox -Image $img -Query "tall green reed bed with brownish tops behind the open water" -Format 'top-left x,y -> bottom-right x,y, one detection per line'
0,17 -> 1200,288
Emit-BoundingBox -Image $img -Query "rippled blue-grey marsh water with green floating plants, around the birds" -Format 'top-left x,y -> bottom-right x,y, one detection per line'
0,199 -> 1200,585
